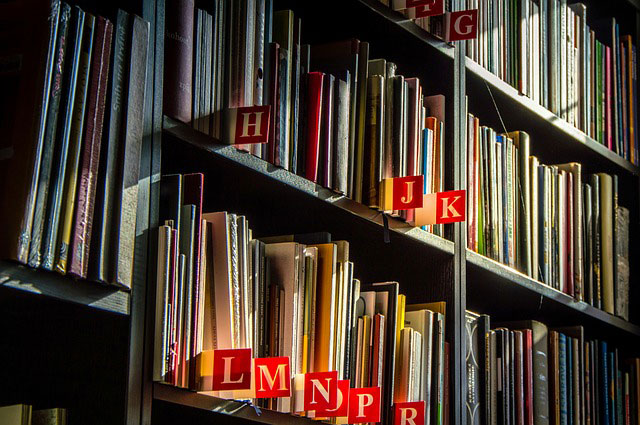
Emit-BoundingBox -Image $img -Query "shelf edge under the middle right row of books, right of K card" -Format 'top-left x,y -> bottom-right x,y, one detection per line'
466,249 -> 640,337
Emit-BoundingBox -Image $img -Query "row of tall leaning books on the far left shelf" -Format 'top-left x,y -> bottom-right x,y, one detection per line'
0,1 -> 149,287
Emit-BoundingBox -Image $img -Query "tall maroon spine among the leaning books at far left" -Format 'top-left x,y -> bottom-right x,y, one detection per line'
69,17 -> 113,278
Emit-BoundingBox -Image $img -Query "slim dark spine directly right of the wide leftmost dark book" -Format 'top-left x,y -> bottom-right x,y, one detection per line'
28,3 -> 71,267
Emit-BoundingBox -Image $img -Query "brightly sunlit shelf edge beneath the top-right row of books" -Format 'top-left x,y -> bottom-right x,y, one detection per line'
466,58 -> 640,176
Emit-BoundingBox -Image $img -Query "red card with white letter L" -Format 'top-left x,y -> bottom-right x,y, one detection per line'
212,348 -> 251,391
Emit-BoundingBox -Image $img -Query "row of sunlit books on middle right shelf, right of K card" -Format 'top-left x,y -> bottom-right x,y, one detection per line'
467,114 -> 629,320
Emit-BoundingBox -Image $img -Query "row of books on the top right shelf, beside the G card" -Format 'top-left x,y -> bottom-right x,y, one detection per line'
467,0 -> 640,164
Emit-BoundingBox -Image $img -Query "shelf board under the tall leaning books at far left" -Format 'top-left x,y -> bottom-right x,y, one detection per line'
0,261 -> 130,315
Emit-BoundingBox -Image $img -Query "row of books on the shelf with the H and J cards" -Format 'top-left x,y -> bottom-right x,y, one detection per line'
164,0 -> 445,234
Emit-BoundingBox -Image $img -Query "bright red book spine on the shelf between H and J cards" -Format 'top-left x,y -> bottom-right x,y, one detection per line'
305,72 -> 324,182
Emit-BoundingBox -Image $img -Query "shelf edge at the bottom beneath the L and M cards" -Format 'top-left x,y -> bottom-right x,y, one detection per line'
153,382 -> 323,425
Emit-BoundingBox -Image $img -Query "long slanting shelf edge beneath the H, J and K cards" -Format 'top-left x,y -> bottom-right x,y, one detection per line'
164,116 -> 453,255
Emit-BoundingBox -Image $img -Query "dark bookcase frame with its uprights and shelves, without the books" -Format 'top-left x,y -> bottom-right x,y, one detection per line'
0,0 -> 640,425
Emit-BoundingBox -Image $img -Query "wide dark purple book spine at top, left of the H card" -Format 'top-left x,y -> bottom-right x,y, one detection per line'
163,0 -> 194,123
